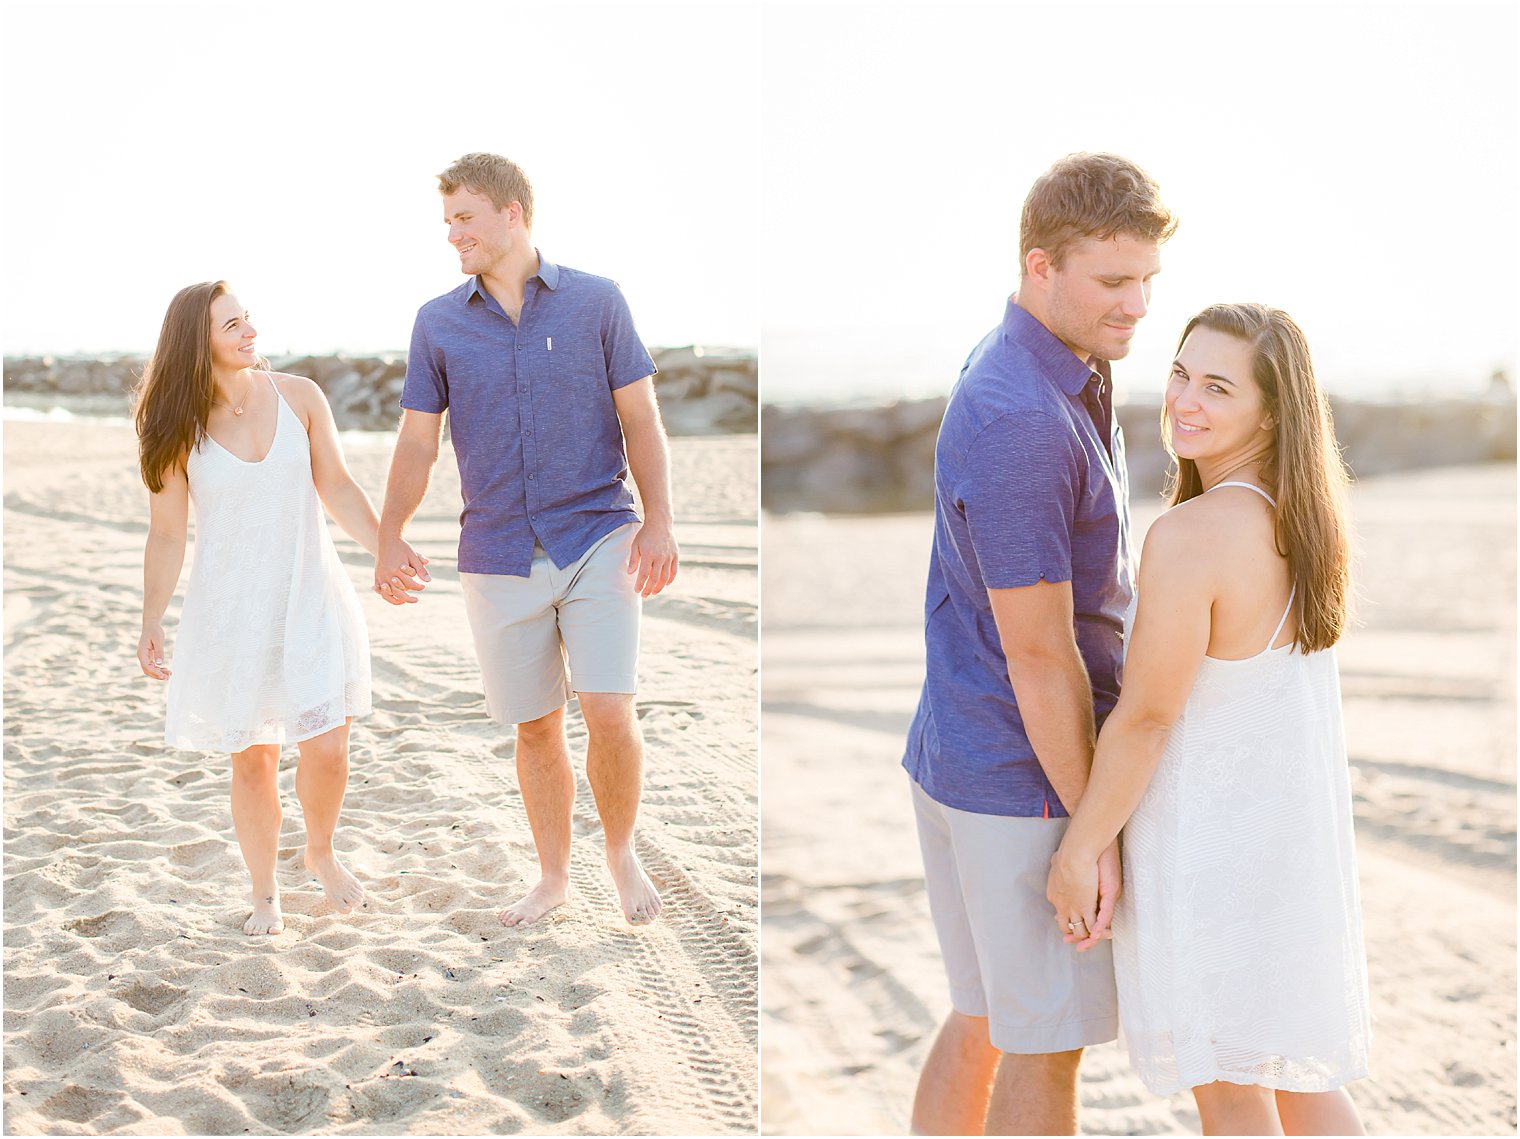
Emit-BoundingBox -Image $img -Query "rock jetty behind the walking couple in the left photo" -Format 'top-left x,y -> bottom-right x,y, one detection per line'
5,345 -> 758,435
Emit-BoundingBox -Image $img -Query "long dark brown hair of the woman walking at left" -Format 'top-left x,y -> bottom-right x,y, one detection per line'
132,281 -> 263,494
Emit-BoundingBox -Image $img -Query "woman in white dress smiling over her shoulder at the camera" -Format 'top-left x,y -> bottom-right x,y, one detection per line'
1049,304 -> 1370,1134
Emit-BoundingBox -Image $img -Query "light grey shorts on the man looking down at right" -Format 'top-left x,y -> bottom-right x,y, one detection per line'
912,783 -> 1119,1052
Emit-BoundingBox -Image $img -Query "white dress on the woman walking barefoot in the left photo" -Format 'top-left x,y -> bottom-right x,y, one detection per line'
164,379 -> 369,753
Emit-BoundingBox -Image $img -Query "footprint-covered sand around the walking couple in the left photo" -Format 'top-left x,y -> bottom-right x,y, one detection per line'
5,420 -> 758,1134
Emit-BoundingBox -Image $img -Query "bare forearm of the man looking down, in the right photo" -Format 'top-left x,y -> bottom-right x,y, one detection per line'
1008,645 -> 1096,814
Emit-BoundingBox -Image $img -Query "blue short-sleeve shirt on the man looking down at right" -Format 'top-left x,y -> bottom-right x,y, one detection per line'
903,301 -> 1134,818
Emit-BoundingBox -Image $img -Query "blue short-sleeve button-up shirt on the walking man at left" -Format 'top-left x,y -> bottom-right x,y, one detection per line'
401,257 -> 655,576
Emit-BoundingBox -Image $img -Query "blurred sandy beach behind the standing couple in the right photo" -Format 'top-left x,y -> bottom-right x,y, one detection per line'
762,465 -> 1515,1134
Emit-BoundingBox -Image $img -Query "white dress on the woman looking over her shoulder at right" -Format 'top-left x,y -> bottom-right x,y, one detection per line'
1113,482 -> 1371,1095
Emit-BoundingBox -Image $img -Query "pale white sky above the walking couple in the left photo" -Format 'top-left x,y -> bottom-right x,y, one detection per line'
0,0 -> 760,354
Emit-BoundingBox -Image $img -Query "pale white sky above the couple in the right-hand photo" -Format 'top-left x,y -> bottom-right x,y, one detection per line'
763,2 -> 1520,400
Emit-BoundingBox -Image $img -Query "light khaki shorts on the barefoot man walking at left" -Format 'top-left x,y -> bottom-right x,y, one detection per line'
459,522 -> 643,725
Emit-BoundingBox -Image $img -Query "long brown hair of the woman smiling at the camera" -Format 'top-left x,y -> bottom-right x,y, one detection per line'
1161,304 -> 1351,654
